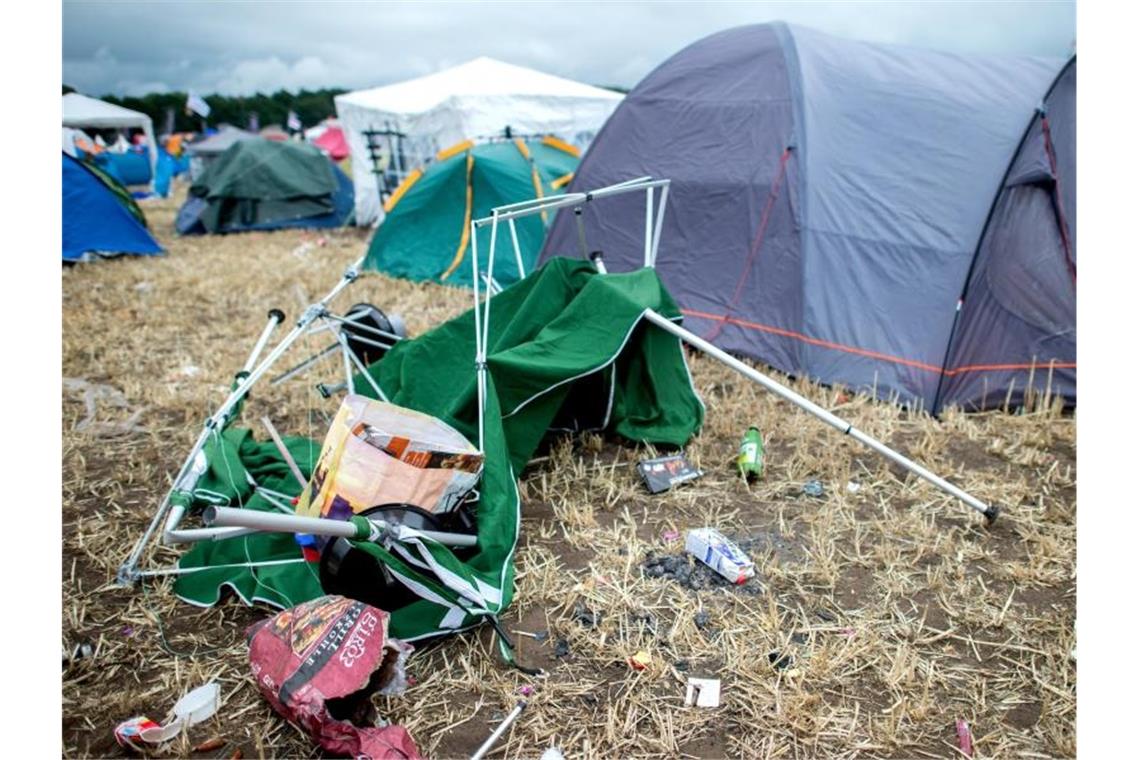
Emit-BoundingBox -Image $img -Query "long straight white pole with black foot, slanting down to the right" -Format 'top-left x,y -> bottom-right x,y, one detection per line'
644,310 -> 999,524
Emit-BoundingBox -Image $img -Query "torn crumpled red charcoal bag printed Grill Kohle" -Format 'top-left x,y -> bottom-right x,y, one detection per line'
247,596 -> 420,760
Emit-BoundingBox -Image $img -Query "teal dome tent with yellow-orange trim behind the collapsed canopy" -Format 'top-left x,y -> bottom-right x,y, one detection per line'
364,137 -> 578,286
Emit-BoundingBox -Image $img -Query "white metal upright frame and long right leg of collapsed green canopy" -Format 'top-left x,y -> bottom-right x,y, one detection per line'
462,177 -> 999,523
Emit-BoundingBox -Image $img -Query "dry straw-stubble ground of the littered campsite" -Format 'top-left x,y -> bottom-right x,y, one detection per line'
62,189 -> 1076,760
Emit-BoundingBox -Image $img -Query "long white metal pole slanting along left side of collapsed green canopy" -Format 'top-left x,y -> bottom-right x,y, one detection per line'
115,256 -> 364,586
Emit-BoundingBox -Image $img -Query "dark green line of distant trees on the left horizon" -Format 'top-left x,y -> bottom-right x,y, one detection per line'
63,84 -> 348,133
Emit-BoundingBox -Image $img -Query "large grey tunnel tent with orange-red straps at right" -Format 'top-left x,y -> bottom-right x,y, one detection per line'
539,23 -> 1076,411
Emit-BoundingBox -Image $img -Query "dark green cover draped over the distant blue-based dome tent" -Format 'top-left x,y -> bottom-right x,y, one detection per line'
189,140 -> 337,232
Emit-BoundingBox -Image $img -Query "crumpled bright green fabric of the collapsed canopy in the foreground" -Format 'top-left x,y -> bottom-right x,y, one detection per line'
176,259 -> 705,640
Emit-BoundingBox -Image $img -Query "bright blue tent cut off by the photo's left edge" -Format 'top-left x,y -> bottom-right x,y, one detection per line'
60,153 -> 162,262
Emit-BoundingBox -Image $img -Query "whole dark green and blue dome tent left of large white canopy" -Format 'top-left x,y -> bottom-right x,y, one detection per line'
176,138 -> 352,235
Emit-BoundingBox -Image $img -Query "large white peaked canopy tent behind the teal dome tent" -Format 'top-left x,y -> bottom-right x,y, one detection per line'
335,58 -> 622,226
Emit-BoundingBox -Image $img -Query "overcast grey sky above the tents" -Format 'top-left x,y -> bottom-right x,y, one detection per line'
63,0 -> 1076,96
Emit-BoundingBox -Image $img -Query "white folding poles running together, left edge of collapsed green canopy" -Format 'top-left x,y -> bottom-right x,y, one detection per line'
115,256 -> 364,586
